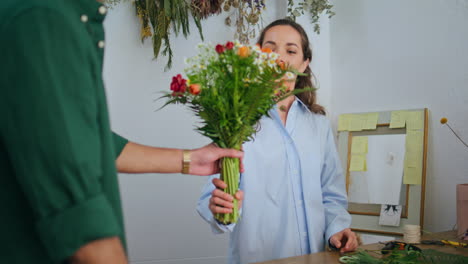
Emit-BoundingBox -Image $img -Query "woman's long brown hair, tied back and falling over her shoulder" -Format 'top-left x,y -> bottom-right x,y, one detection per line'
257,19 -> 325,115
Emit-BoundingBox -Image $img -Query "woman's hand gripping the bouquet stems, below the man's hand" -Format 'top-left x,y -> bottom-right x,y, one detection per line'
209,178 -> 244,214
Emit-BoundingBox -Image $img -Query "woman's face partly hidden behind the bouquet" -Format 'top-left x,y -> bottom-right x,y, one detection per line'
262,25 -> 309,72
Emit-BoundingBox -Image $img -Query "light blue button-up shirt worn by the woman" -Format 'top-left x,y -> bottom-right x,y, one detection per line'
197,99 -> 351,264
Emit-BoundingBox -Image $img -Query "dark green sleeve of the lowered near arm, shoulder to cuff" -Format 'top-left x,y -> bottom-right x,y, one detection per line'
1,9 -> 124,263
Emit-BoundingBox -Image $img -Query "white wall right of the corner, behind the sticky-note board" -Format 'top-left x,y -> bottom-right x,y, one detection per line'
330,0 -> 468,231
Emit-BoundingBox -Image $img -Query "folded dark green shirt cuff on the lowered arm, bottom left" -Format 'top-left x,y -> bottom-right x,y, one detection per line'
36,194 -> 123,263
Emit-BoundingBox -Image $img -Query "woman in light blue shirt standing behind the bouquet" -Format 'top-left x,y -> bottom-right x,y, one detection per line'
197,19 -> 357,264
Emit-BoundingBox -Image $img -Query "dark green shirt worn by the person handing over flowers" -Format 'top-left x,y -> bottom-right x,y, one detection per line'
0,0 -> 127,264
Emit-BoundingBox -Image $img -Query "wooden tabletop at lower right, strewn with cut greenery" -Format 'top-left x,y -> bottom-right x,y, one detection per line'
255,231 -> 468,264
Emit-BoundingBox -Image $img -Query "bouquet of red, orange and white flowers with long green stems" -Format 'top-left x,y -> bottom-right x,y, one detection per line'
163,41 -> 304,224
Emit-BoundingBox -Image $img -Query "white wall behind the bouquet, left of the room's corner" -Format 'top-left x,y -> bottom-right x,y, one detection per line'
104,1 -> 330,264
